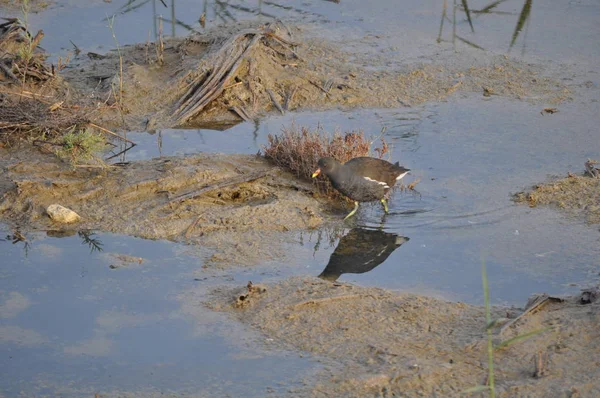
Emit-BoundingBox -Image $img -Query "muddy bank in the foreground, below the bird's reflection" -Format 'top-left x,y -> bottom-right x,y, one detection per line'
209,278 -> 600,397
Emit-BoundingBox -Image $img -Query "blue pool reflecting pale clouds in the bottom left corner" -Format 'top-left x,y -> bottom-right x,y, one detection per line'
0,228 -> 324,397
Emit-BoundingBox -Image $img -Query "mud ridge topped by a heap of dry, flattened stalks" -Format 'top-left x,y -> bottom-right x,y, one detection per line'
62,23 -> 571,130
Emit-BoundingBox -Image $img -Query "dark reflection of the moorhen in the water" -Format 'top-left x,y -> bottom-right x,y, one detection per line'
319,228 -> 409,282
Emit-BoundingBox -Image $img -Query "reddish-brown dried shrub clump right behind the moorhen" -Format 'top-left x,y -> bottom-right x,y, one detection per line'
263,125 -> 389,197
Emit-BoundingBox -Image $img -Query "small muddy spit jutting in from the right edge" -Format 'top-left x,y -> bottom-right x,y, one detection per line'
514,163 -> 600,224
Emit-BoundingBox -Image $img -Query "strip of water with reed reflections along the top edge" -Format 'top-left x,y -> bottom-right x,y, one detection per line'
25,0 -> 600,70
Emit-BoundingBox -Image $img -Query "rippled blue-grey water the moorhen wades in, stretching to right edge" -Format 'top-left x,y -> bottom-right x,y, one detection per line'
126,95 -> 600,304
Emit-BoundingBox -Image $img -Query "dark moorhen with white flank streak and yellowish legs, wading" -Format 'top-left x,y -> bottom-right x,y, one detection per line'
312,157 -> 410,220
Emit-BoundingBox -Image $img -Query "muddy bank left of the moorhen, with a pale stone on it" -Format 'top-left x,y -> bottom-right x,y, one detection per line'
0,149 -> 324,265
